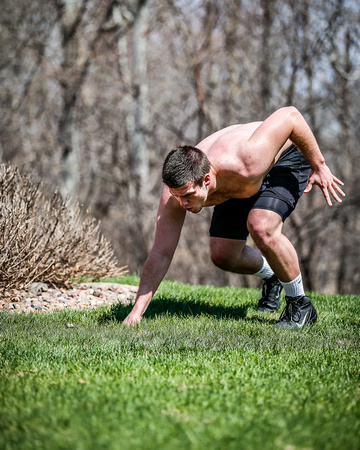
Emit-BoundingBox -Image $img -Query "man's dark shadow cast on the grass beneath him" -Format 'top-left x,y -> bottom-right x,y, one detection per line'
100,297 -> 261,322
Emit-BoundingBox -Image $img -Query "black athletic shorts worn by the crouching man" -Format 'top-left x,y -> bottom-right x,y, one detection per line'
210,144 -> 310,240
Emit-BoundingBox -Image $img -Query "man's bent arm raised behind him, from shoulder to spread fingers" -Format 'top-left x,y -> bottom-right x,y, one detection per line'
248,106 -> 345,206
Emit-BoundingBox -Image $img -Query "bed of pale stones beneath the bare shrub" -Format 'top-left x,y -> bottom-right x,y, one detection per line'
0,283 -> 138,313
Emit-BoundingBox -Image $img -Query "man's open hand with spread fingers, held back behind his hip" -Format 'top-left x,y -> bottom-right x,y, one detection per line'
304,164 -> 345,206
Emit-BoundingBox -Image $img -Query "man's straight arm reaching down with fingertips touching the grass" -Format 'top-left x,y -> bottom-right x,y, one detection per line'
124,186 -> 186,325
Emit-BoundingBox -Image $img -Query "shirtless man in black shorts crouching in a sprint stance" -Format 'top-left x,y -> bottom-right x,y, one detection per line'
124,107 -> 345,328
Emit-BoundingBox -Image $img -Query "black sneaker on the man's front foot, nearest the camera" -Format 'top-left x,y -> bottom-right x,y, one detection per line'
275,295 -> 317,328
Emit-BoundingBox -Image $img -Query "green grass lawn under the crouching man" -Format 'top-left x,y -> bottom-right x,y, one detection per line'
0,278 -> 360,450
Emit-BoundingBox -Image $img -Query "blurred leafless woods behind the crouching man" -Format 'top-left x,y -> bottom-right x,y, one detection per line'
0,0 -> 360,294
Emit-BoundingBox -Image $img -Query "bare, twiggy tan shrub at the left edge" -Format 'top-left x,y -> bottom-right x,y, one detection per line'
0,164 -> 125,290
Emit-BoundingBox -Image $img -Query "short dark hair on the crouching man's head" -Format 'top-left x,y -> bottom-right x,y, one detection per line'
162,145 -> 210,189
